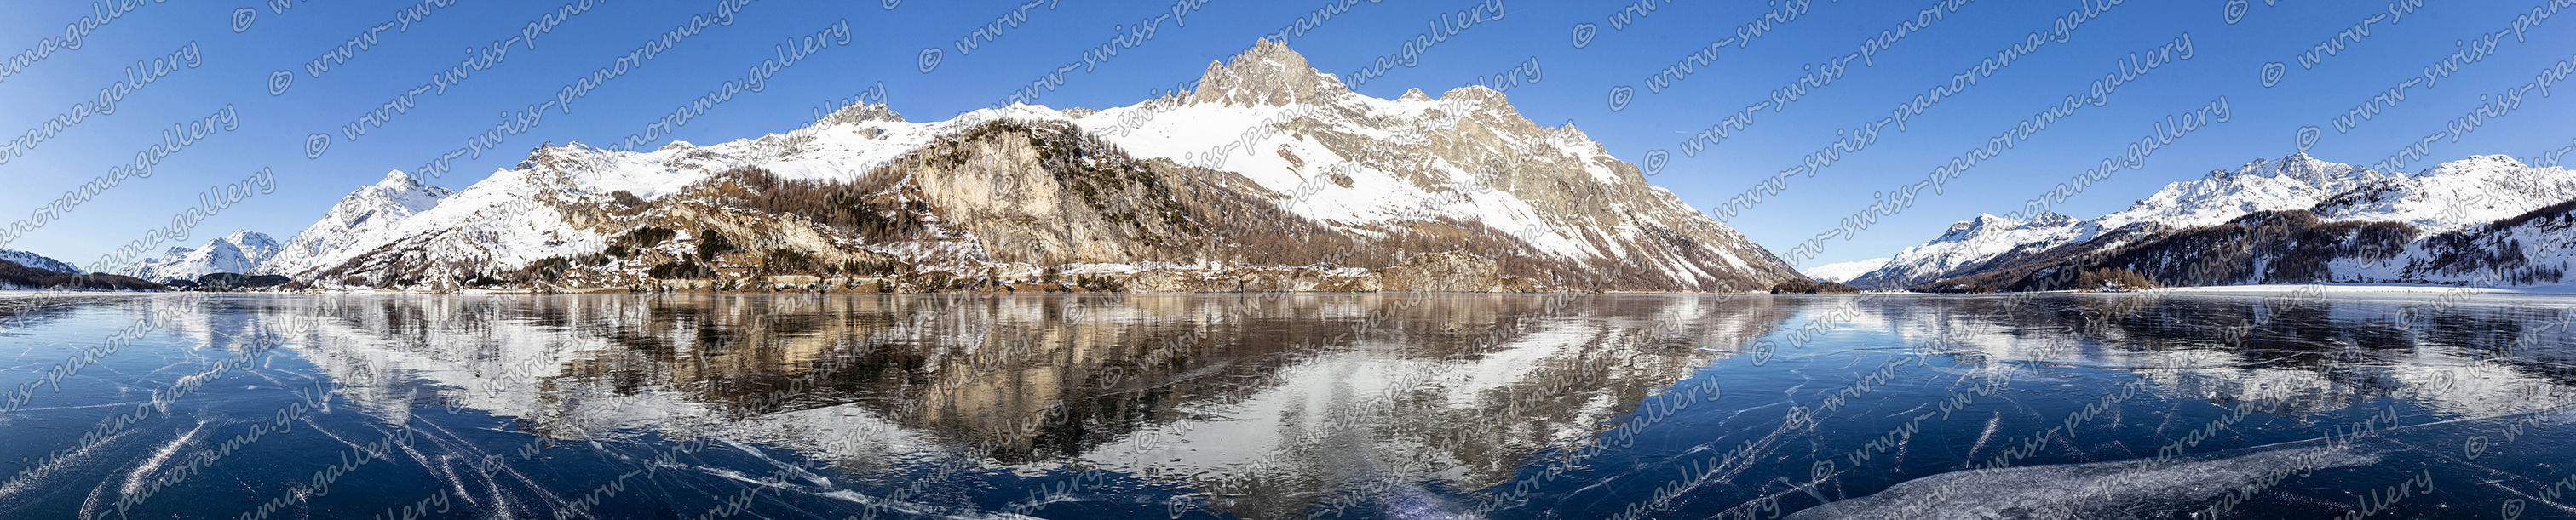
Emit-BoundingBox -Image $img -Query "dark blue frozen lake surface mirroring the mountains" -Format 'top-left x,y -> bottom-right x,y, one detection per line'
0,294 -> 2576,520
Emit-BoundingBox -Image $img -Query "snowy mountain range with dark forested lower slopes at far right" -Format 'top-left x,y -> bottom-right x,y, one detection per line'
1849,154 -> 2576,291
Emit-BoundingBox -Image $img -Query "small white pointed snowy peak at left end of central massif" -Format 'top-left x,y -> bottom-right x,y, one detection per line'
255,170 -> 453,276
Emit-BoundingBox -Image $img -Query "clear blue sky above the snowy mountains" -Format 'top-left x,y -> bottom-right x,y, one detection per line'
0,0 -> 2576,266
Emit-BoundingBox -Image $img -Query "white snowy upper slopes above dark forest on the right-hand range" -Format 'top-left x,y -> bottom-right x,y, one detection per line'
1854,154 -> 2576,289
